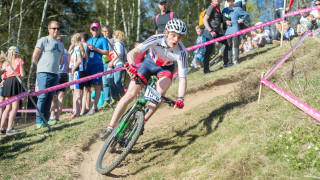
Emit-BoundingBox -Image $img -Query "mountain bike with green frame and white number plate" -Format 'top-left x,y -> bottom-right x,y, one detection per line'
96,76 -> 174,175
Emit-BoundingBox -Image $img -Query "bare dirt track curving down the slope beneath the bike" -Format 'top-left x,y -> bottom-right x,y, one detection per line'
73,80 -> 235,180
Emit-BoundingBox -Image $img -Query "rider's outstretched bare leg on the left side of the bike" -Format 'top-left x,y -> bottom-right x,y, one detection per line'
110,81 -> 141,127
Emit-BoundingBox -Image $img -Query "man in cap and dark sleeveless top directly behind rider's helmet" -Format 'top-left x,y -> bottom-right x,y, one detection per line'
154,0 -> 178,34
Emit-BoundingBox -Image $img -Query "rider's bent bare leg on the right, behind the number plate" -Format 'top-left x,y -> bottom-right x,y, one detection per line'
145,77 -> 172,120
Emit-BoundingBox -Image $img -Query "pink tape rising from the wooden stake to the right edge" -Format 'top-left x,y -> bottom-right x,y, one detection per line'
264,28 -> 320,79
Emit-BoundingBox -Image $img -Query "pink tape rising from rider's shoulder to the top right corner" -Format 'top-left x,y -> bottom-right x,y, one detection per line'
186,6 -> 320,51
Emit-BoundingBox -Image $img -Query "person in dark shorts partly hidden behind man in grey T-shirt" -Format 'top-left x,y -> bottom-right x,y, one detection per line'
49,36 -> 70,121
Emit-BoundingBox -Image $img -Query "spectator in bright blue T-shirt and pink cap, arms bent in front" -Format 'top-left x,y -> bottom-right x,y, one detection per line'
84,23 -> 109,115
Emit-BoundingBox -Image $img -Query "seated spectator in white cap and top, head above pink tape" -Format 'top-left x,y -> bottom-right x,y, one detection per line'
251,22 -> 272,48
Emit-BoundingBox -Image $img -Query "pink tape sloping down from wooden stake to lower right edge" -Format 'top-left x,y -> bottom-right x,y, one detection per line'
261,78 -> 320,122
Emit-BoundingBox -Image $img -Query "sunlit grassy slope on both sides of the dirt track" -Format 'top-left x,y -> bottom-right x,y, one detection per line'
0,39 -> 320,179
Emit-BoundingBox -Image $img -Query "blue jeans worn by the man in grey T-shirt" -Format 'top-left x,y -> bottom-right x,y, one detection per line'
37,72 -> 58,124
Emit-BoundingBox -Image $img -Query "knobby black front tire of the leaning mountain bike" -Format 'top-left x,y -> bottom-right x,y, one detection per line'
96,110 -> 144,175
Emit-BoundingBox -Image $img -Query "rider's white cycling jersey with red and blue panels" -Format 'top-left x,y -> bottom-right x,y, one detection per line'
137,34 -> 187,77
